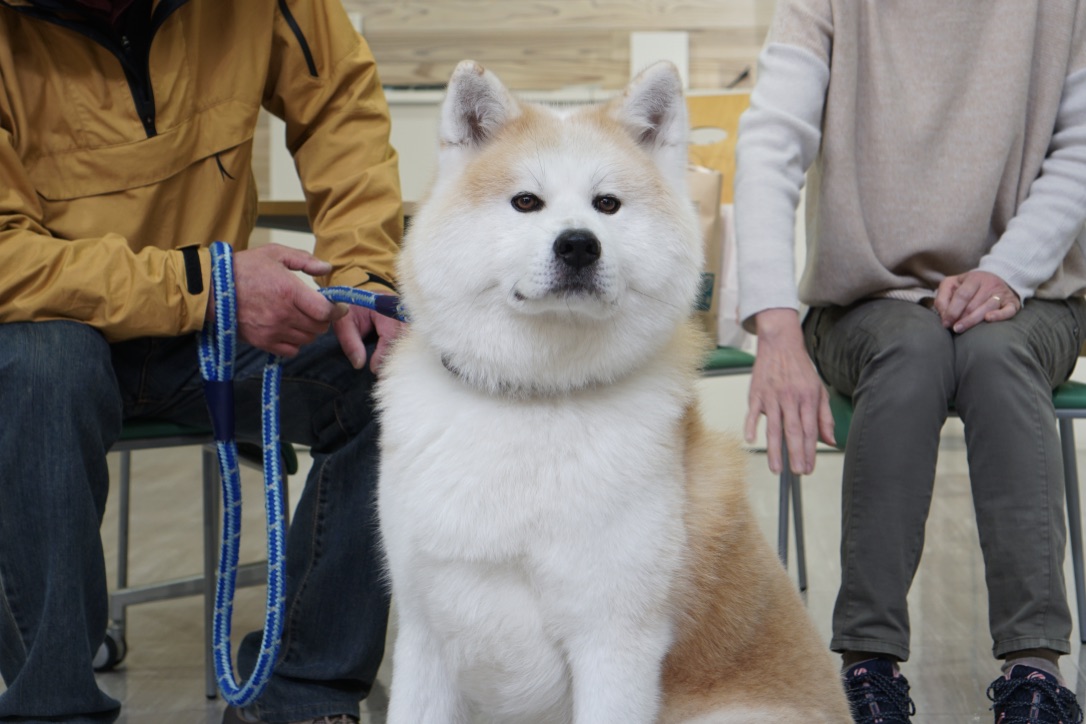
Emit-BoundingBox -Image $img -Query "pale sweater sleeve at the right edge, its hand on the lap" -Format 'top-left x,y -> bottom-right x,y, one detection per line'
977,63 -> 1086,301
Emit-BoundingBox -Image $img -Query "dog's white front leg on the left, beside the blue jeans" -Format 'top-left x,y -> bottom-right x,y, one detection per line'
387,610 -> 467,724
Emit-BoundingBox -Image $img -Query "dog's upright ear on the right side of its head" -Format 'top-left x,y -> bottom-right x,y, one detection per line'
611,61 -> 690,168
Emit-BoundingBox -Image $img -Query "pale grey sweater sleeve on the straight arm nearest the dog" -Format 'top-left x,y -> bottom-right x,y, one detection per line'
735,40 -> 830,330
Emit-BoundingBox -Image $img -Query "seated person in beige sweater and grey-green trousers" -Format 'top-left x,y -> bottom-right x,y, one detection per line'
735,0 -> 1086,723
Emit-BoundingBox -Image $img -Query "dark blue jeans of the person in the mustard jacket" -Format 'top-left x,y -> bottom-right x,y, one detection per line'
0,321 -> 389,722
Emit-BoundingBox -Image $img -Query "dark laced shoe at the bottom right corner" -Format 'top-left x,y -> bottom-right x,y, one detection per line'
988,663 -> 1083,724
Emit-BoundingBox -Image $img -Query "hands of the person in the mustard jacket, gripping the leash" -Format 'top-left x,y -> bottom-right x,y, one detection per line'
207,244 -> 403,373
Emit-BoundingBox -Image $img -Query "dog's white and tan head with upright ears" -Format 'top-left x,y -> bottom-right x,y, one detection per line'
400,61 -> 702,394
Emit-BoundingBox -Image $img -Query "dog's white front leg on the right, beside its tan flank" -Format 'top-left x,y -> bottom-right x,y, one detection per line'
569,620 -> 671,724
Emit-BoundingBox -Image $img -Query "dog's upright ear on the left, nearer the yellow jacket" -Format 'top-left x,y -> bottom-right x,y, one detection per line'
441,61 -> 520,149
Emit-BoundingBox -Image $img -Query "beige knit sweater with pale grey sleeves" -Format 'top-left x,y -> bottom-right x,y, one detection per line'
735,0 -> 1086,321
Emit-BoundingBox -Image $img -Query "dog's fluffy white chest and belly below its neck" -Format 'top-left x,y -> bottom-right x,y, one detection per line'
379,340 -> 683,721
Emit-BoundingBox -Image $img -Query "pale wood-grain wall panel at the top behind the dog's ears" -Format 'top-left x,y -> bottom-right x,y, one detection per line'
344,0 -> 773,90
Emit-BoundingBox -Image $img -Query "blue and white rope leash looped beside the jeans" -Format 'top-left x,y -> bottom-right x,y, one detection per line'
200,241 -> 405,707
